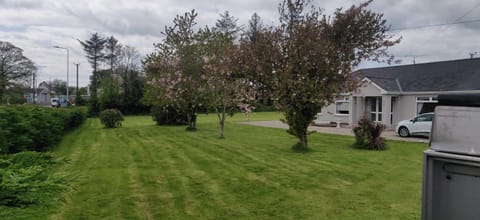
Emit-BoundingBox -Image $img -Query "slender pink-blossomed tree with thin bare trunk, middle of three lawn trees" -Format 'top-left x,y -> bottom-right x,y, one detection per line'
202,11 -> 246,138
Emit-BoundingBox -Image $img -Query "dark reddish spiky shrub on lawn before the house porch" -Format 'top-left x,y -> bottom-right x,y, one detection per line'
352,117 -> 386,150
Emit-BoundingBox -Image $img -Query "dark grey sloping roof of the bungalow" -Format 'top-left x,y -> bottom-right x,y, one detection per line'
354,58 -> 480,92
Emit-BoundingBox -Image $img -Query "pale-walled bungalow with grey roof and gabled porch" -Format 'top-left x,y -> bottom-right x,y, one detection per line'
316,58 -> 480,127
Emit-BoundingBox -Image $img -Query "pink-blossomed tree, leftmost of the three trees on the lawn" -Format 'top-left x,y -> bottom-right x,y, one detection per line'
143,10 -> 206,130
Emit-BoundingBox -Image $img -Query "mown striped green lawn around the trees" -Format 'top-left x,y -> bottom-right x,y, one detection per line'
0,113 -> 427,219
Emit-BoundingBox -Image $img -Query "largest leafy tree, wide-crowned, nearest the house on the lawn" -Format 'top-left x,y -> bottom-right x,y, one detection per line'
270,0 -> 400,149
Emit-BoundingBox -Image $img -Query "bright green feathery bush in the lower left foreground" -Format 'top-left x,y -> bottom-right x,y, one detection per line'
0,152 -> 66,207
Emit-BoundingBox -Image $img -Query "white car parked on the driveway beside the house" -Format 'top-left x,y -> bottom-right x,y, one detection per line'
395,112 -> 433,137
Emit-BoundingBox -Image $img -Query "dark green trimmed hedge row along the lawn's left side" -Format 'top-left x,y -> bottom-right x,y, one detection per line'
0,106 -> 87,154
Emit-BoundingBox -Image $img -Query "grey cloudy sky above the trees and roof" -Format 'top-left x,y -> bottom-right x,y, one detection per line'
0,0 -> 480,86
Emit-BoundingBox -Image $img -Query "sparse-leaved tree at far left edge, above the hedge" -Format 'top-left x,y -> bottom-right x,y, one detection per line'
0,41 -> 37,100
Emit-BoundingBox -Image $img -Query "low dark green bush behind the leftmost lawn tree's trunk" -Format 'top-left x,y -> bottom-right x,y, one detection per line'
152,106 -> 188,125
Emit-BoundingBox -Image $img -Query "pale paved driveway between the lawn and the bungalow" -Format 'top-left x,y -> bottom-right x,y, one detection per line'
240,121 -> 428,143
